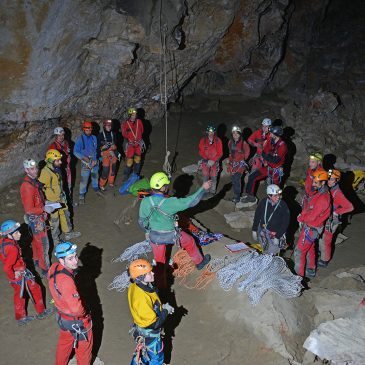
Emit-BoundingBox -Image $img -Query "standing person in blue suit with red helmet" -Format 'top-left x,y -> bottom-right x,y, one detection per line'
74,120 -> 103,205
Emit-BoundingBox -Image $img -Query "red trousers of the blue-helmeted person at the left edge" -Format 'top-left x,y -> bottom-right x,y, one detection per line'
11,280 -> 46,320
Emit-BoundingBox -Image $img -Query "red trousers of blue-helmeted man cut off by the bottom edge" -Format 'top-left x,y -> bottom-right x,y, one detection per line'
55,320 -> 93,365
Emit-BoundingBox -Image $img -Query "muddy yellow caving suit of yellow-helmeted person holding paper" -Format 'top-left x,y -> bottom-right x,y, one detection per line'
39,163 -> 72,245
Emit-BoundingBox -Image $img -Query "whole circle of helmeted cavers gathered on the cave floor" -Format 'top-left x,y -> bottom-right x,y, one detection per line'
0,108 -> 353,365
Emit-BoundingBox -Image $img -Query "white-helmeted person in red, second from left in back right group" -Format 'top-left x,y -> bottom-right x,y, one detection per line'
228,126 -> 250,204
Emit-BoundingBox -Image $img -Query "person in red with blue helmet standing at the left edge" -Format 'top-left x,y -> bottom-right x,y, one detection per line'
0,219 -> 52,326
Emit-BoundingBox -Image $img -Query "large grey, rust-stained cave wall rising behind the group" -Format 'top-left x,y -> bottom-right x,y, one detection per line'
0,0 -> 365,186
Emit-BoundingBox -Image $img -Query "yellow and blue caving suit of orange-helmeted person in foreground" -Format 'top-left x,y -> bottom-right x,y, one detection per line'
128,282 -> 168,365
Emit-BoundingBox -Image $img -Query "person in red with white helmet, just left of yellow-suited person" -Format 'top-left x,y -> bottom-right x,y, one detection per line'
20,158 -> 54,277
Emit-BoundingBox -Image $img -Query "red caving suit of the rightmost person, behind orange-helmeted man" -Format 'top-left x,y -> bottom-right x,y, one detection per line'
319,184 -> 354,262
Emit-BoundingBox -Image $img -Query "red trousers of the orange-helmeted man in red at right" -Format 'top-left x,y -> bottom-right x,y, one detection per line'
294,227 -> 316,277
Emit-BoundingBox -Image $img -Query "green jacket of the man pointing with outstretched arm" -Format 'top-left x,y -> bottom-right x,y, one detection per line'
138,187 -> 204,231
